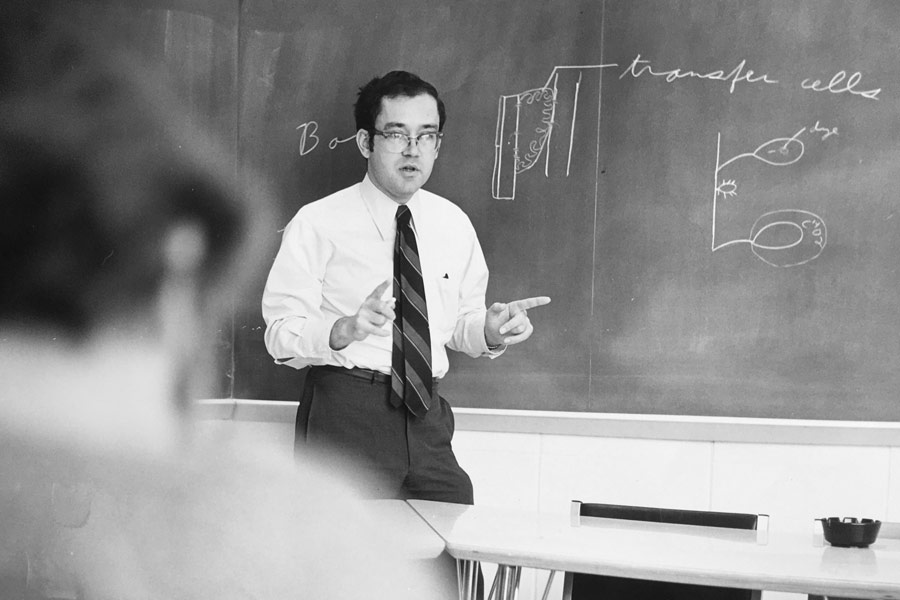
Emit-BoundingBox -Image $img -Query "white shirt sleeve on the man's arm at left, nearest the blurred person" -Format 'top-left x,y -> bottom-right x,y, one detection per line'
262,210 -> 338,369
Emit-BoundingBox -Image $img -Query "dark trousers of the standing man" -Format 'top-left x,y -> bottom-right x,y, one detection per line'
294,367 -> 484,598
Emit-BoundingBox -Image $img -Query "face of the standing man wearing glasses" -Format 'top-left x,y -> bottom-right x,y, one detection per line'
360,94 -> 439,204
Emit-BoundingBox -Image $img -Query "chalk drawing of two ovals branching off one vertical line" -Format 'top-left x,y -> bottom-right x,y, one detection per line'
712,127 -> 827,267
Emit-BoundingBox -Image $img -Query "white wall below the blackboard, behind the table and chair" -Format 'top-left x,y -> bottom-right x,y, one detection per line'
201,400 -> 900,600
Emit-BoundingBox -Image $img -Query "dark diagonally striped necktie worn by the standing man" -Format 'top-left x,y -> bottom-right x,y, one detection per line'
391,204 -> 433,417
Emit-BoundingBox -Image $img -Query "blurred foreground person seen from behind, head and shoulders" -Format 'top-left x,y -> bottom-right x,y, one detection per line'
0,0 -> 450,600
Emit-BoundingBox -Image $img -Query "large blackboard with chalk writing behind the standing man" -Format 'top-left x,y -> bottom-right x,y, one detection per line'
65,0 -> 900,420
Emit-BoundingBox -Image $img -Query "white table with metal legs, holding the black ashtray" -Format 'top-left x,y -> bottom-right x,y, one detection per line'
409,500 -> 900,600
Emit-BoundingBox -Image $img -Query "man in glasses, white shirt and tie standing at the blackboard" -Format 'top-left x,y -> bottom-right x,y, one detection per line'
262,71 -> 550,504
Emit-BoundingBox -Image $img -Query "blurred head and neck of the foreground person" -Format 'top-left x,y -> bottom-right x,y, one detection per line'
0,0 -> 271,436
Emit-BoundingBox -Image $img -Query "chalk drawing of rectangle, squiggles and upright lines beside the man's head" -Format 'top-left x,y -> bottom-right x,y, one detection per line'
491,65 -> 616,200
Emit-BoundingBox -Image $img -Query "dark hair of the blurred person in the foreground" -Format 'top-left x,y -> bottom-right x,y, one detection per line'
0,0 -> 271,338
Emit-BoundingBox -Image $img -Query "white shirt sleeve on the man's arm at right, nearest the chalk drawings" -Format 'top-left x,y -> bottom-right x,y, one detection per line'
447,223 -> 506,358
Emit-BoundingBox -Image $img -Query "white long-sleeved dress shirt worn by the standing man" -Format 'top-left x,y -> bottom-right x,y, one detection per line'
262,175 -> 500,377
